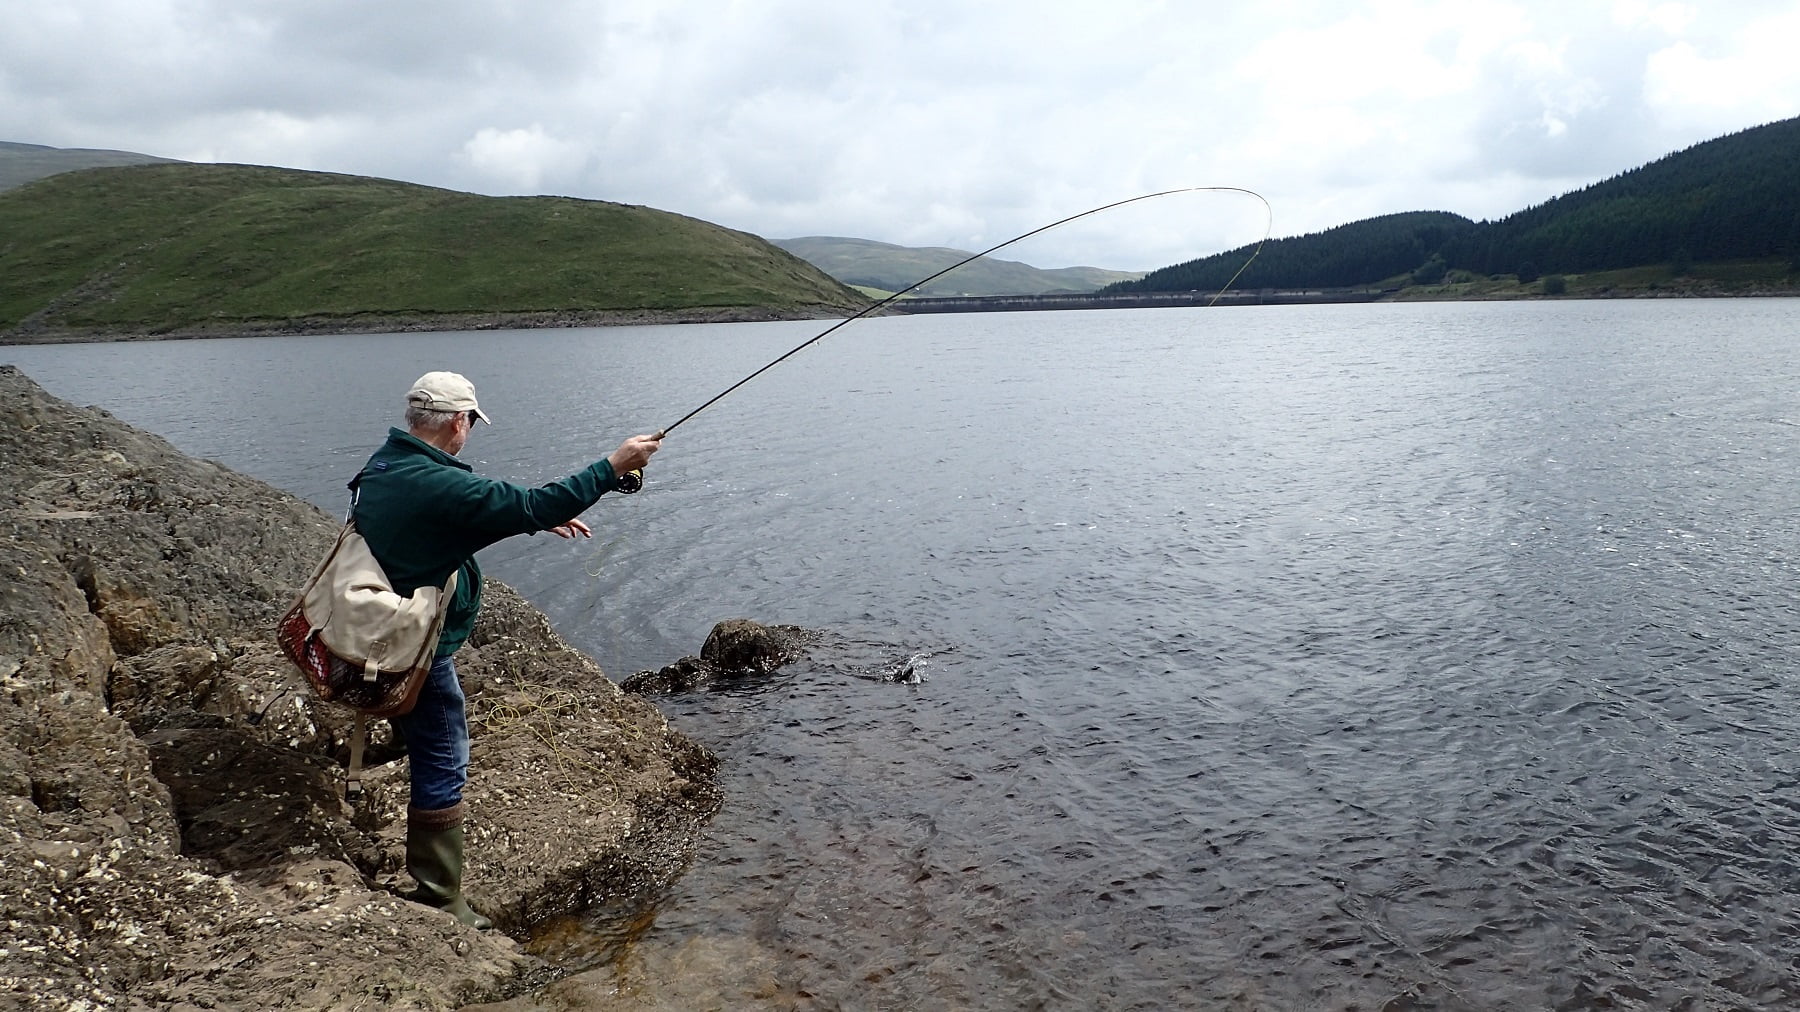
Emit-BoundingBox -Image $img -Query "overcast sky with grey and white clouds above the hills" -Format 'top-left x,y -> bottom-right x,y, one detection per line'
0,0 -> 1800,268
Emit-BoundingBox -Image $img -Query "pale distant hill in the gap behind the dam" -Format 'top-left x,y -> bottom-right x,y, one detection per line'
774,236 -> 1139,297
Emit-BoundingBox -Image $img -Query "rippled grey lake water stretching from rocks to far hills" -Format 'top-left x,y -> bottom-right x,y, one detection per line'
10,299 -> 1800,1010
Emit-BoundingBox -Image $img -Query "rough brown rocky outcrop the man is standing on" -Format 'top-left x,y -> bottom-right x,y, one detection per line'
0,366 -> 718,1008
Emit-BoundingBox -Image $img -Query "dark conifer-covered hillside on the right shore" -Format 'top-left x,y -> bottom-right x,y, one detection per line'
1109,117 -> 1800,294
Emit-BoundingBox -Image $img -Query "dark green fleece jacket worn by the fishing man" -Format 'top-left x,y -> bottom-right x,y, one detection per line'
355,429 -> 619,657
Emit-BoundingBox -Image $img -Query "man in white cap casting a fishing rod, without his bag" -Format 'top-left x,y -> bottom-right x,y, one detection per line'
355,373 -> 662,929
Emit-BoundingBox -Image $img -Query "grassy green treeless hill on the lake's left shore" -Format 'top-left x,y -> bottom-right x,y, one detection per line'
0,164 -> 866,340
